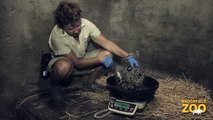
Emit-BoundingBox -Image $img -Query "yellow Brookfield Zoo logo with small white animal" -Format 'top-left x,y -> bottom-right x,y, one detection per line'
182,100 -> 207,115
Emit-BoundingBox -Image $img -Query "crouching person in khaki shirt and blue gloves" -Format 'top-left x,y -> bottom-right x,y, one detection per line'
48,1 -> 138,90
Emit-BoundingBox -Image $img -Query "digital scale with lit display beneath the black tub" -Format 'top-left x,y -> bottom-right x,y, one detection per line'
108,98 -> 147,116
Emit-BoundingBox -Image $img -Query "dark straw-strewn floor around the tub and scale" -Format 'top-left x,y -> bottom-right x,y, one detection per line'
13,72 -> 213,120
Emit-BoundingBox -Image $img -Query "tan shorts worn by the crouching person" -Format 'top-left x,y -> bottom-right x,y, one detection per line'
48,49 -> 101,72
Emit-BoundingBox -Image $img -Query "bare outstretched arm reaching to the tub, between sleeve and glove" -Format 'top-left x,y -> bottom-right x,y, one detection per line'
94,34 -> 129,58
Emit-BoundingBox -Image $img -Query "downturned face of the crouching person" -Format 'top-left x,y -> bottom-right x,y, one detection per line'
64,20 -> 81,37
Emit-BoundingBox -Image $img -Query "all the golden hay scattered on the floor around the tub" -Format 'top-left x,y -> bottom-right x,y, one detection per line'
14,70 -> 213,120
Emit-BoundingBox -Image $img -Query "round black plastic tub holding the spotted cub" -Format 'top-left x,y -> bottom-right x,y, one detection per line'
107,76 -> 159,102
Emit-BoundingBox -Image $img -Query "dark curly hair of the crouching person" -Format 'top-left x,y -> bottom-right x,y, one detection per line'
54,1 -> 81,29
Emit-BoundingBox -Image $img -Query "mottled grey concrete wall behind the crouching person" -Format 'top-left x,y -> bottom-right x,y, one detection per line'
0,0 -> 213,118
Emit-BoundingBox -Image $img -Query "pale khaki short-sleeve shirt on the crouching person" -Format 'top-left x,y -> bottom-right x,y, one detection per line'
48,18 -> 101,58
